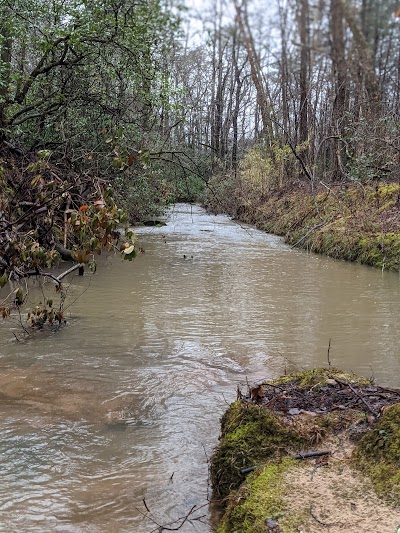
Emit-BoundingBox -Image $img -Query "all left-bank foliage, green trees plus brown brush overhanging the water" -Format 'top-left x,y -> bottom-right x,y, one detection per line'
0,0 -> 187,327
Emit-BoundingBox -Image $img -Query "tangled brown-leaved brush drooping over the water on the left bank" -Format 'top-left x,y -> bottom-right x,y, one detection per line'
0,145 -> 136,328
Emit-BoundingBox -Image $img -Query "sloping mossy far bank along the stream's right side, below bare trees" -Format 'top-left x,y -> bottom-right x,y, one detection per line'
207,183 -> 400,271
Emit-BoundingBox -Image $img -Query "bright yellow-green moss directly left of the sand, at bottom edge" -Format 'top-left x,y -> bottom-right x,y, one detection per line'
218,458 -> 302,533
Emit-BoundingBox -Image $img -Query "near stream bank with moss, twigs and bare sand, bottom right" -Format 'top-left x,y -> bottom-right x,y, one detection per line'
214,368 -> 400,533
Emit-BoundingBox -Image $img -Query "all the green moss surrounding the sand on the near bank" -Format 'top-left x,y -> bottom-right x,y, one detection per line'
214,368 -> 400,533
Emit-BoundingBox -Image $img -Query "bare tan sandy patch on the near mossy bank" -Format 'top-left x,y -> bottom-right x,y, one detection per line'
285,439 -> 400,533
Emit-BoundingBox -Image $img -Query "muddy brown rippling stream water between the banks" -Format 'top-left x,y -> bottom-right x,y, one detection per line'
0,205 -> 400,533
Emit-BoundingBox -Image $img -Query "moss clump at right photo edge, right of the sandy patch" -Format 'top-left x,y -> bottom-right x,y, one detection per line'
353,404 -> 400,505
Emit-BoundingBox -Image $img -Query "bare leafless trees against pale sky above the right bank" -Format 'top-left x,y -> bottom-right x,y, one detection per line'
195,0 -> 399,197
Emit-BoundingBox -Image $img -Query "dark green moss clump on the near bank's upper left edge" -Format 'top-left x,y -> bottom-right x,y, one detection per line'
210,401 -> 305,498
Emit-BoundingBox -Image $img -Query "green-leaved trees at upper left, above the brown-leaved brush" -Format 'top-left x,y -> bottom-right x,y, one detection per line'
0,0 -> 186,220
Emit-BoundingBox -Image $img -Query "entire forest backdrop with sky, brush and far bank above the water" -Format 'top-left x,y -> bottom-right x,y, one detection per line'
0,0 -> 400,319
